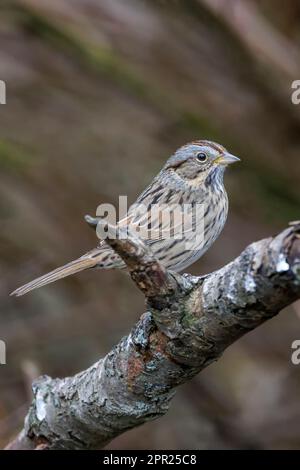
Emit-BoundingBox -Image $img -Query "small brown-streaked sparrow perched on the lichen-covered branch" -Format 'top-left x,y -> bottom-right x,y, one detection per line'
10,140 -> 240,296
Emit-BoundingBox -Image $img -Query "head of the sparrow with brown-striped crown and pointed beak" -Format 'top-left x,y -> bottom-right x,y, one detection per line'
164,140 -> 240,186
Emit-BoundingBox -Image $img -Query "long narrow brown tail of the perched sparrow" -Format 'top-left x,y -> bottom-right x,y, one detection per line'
10,248 -> 102,297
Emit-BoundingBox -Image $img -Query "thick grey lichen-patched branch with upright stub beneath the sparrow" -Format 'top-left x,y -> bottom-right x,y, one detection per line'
7,222 -> 300,449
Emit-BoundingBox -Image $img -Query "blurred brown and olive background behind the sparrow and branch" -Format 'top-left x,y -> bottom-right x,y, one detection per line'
0,0 -> 300,449
